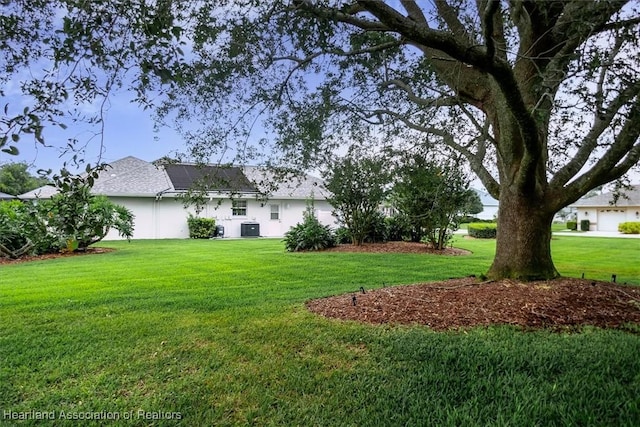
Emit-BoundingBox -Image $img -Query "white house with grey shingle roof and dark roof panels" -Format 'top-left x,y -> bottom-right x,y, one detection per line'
20,157 -> 334,240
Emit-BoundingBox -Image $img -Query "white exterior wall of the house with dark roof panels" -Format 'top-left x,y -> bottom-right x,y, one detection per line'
105,197 -> 333,240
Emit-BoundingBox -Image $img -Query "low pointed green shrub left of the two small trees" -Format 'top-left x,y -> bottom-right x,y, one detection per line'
284,205 -> 336,252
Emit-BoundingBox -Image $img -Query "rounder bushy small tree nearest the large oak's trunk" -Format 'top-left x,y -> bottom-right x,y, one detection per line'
392,155 -> 475,249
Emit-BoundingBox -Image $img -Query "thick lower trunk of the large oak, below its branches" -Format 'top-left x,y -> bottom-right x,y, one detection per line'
487,187 -> 560,280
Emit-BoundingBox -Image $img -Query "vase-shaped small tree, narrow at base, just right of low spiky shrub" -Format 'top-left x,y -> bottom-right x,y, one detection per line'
325,150 -> 389,245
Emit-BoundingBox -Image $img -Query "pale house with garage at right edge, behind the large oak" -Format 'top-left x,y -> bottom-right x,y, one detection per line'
571,185 -> 640,231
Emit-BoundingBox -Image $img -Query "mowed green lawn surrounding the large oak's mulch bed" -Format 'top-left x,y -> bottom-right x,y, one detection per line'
0,237 -> 640,426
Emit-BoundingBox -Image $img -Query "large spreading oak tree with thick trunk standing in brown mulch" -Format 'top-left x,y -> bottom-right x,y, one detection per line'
166,0 -> 640,280
